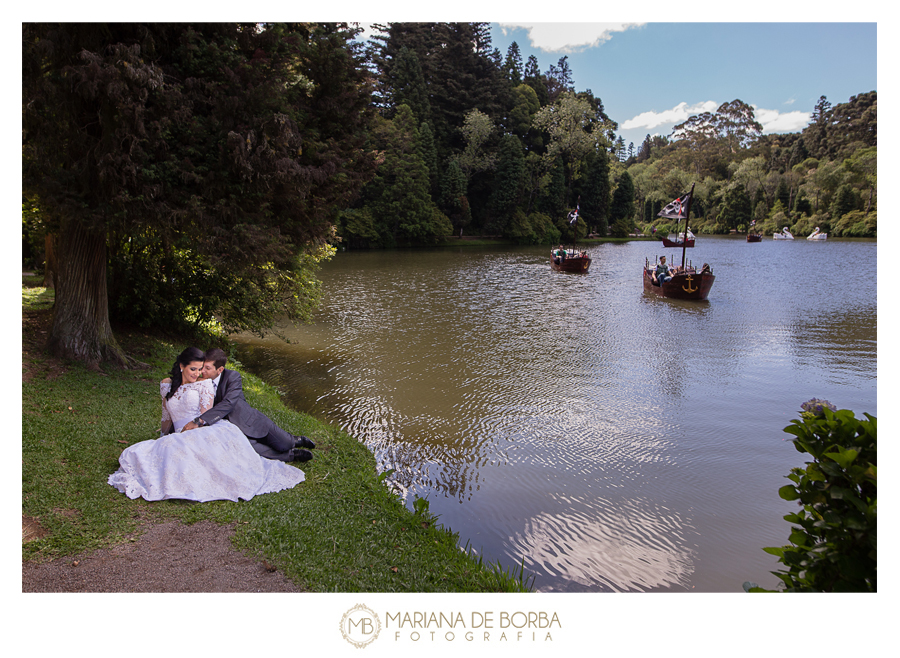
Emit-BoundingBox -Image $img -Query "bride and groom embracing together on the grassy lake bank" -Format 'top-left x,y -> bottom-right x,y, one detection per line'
108,347 -> 315,502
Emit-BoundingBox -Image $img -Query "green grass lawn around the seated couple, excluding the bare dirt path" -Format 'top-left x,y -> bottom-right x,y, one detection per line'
22,279 -> 527,592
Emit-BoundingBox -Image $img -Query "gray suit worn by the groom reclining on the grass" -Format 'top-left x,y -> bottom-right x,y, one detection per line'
200,369 -> 295,462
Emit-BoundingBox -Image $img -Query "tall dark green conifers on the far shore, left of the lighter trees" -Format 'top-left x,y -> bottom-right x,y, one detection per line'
338,23 -> 617,247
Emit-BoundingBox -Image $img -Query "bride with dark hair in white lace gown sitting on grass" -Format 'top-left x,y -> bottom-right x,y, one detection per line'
108,347 -> 305,502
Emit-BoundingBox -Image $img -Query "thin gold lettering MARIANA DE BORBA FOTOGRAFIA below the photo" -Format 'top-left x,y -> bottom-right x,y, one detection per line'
384,611 -> 562,642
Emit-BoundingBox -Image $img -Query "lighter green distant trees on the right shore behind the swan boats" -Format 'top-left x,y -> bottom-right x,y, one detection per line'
625,91 -> 878,237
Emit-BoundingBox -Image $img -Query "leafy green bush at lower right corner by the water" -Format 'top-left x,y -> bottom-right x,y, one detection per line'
744,399 -> 878,592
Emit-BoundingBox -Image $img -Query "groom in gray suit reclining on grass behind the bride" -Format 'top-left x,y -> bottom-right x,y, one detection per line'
182,347 -> 316,462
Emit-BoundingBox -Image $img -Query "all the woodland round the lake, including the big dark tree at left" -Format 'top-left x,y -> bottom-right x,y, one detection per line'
22,23 -> 877,365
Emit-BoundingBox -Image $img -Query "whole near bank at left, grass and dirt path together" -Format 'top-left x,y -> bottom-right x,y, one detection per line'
21,274 -> 530,592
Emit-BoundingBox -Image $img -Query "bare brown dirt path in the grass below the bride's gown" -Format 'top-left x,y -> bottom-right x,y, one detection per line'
22,521 -> 303,592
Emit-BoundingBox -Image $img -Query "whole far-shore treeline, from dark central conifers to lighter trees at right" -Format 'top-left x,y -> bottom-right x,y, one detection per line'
338,23 -> 877,248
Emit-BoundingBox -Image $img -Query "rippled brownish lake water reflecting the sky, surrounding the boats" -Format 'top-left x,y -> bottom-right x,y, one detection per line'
232,236 -> 877,592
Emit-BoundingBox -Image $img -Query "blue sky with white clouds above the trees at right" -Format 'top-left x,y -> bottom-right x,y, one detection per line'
491,22 -> 878,147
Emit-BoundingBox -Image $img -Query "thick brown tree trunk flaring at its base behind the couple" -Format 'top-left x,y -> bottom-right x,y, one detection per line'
47,221 -> 129,369
